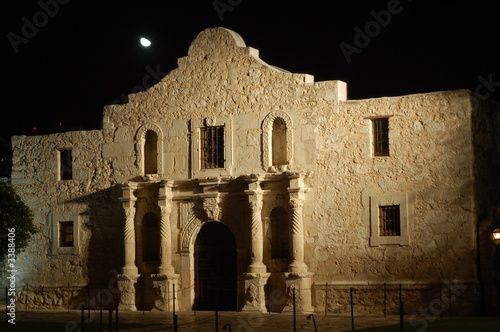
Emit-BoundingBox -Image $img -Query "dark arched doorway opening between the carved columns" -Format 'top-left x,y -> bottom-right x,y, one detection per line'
194,222 -> 237,310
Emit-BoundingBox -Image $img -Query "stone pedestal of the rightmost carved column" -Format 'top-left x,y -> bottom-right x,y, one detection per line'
283,272 -> 314,314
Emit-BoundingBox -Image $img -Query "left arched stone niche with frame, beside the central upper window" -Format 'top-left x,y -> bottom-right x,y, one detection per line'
135,123 -> 163,175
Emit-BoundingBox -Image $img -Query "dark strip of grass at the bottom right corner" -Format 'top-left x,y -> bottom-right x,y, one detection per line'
357,317 -> 500,332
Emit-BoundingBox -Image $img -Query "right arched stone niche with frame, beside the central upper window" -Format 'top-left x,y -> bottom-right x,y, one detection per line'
262,111 -> 293,172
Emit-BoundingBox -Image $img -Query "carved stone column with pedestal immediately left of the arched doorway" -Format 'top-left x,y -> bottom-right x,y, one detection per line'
151,181 -> 179,311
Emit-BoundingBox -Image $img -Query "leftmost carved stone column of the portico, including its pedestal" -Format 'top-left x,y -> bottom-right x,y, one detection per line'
117,184 -> 139,310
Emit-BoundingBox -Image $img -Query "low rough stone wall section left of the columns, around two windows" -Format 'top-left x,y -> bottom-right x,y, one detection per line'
12,131 -> 123,286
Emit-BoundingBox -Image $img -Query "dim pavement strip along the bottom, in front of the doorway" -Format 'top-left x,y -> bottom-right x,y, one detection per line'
0,309 -> 399,332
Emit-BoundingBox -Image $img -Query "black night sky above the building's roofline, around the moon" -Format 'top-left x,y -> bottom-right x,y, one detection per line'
0,0 -> 500,174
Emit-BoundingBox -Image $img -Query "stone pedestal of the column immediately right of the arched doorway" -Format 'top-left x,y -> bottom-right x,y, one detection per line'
242,273 -> 271,312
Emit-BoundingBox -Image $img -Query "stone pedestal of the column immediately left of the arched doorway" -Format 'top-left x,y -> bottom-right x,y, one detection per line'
151,273 -> 179,312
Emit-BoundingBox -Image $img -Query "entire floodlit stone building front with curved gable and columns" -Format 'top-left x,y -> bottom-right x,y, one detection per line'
7,28 -> 500,312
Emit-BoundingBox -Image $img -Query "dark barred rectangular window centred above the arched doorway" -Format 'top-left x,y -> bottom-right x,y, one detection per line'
200,126 -> 225,169
